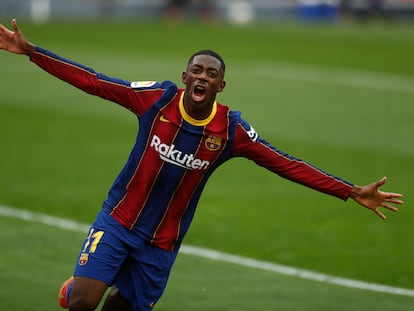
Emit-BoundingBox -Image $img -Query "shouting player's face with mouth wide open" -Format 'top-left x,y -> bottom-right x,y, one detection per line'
182,55 -> 226,108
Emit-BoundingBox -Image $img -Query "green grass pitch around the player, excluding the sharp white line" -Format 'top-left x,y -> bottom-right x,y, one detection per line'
0,20 -> 414,311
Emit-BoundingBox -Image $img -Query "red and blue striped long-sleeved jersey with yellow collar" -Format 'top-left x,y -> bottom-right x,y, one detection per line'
31,47 -> 353,250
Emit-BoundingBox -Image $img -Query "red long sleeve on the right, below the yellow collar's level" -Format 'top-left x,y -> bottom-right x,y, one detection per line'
233,119 -> 353,200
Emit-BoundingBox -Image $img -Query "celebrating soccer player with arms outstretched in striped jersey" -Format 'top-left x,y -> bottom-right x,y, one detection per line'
0,19 -> 403,311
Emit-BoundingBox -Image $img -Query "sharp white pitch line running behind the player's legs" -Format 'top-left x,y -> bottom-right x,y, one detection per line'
0,205 -> 414,297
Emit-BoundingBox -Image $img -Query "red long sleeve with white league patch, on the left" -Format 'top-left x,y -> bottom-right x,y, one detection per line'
30,47 -> 164,115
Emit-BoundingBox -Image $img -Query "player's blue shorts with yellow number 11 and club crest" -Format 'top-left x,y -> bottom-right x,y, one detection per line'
74,212 -> 177,311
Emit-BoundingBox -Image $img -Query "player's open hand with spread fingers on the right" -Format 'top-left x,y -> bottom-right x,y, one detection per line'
350,177 -> 404,219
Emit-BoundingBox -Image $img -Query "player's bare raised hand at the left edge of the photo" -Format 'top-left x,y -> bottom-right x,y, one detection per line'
0,18 -> 35,57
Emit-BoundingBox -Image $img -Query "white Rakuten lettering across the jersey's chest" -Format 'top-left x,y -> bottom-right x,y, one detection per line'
150,135 -> 210,170
